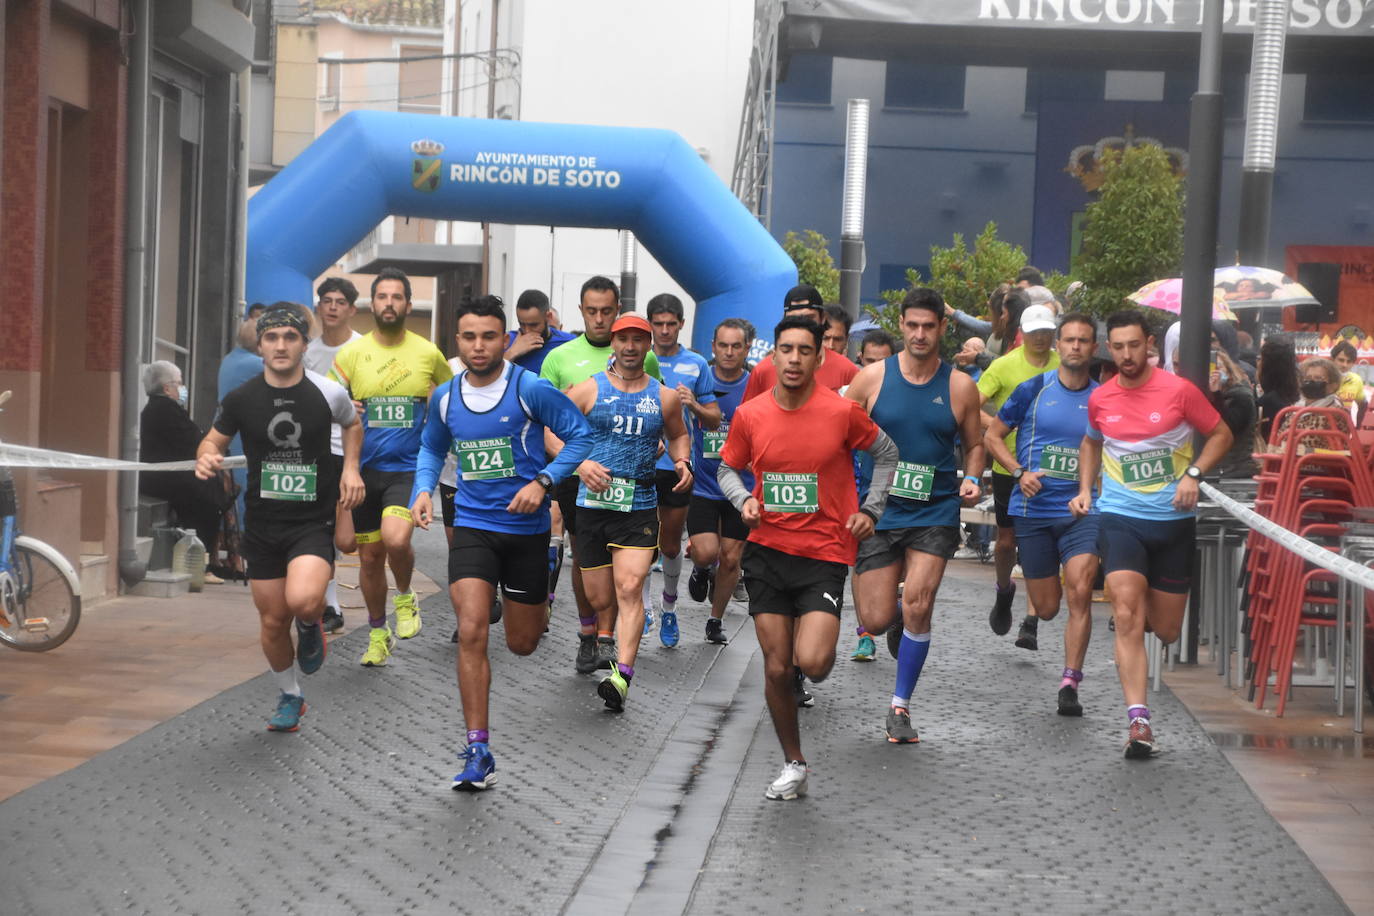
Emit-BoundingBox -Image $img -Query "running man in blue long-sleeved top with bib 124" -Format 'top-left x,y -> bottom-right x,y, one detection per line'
411,295 -> 592,792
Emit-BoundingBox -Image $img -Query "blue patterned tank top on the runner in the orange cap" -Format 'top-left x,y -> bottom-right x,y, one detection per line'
577,372 -> 664,509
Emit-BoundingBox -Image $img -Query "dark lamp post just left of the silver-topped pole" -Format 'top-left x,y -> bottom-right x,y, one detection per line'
1179,0 -> 1221,391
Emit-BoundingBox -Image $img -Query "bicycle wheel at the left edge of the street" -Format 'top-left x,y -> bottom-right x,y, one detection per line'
0,544 -> 81,652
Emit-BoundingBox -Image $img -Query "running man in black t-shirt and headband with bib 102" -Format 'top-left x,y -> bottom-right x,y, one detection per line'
195,306 -> 363,732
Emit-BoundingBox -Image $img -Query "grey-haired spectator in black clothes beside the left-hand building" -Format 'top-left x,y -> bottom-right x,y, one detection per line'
139,360 -> 229,585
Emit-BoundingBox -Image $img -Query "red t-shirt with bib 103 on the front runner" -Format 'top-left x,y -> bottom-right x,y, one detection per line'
720,385 -> 878,566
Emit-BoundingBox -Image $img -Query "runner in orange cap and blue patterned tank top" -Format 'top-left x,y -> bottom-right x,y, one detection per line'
567,314 -> 692,713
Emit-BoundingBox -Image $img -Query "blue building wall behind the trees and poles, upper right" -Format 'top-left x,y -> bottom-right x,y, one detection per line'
772,54 -> 1374,301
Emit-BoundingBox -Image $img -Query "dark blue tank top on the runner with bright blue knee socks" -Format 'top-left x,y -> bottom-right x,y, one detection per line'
871,353 -> 959,530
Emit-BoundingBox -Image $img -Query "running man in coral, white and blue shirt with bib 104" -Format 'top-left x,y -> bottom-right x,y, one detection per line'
1069,309 -> 1231,759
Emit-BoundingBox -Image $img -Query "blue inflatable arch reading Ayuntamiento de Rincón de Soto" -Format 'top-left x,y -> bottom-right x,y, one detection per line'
246,111 -> 797,350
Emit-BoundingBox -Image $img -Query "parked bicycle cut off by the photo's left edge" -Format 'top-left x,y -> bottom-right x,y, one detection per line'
0,391 -> 81,652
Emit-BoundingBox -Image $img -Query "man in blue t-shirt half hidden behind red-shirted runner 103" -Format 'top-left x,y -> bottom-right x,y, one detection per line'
687,319 -> 753,645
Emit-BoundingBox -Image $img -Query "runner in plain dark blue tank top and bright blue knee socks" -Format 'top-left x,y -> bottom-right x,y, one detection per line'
846,287 -> 984,744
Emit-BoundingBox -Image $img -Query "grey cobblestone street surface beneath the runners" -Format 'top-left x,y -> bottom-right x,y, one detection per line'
0,533 -> 1347,916
